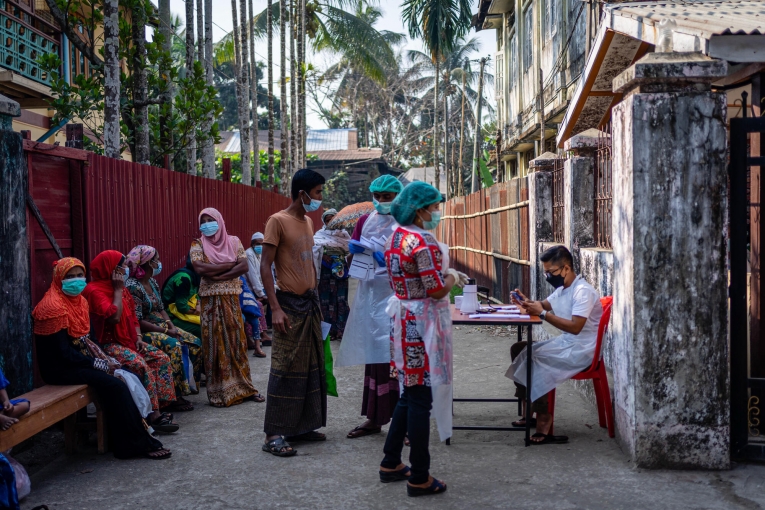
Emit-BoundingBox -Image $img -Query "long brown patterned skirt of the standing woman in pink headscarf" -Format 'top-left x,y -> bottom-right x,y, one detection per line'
200,295 -> 258,407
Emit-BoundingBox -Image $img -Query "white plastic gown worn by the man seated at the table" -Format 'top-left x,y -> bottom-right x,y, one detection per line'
505,276 -> 603,402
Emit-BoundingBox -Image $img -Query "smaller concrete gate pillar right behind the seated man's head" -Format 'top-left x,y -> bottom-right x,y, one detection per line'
563,129 -> 601,273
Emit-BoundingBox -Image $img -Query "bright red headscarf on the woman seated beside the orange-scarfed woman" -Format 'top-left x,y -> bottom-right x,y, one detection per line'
83,250 -> 138,349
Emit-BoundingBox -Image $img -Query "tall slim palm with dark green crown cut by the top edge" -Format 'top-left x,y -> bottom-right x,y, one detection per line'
401,0 -> 472,188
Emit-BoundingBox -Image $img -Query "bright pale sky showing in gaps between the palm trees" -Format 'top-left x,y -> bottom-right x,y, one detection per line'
167,0 -> 496,129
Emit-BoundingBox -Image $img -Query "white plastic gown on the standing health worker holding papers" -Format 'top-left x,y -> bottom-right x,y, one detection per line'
335,211 -> 398,367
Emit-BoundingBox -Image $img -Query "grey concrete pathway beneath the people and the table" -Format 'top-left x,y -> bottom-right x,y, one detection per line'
16,327 -> 765,510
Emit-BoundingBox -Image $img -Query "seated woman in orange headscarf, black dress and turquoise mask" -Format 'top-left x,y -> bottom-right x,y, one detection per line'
32,257 -> 171,459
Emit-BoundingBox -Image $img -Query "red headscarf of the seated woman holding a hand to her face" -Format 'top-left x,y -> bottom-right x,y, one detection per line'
83,250 -> 138,348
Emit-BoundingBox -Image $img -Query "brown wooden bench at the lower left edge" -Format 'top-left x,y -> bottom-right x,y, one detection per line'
0,384 -> 106,453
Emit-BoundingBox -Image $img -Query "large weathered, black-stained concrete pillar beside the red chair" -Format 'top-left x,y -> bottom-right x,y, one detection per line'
611,53 -> 730,469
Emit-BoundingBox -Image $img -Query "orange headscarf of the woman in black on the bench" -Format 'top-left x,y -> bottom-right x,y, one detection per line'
32,257 -> 90,338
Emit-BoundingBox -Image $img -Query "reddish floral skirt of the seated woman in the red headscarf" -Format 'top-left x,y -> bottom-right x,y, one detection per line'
102,343 -> 175,411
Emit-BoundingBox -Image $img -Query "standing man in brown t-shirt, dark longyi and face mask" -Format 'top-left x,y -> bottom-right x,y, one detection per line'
260,168 -> 327,457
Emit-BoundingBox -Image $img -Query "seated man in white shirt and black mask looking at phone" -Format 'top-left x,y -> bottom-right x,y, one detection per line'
505,246 -> 603,444
